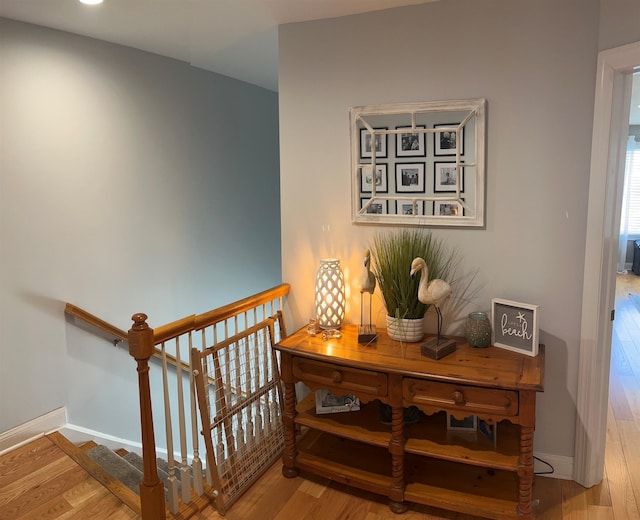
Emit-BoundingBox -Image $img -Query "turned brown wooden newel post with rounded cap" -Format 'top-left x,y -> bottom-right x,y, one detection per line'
129,313 -> 166,520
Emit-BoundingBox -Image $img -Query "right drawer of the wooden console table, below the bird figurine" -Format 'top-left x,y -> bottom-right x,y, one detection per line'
402,378 -> 518,416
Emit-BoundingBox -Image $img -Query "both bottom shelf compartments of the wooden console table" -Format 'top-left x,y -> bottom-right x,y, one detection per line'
296,430 -> 526,519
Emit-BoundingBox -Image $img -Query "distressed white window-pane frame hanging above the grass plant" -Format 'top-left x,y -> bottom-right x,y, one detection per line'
350,99 -> 486,227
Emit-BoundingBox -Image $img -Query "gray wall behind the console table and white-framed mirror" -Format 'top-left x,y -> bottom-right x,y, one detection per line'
279,0 -> 599,466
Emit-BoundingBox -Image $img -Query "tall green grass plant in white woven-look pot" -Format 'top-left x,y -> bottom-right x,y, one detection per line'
370,228 -> 460,342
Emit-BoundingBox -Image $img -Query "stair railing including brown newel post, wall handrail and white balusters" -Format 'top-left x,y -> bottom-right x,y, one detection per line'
65,284 -> 290,520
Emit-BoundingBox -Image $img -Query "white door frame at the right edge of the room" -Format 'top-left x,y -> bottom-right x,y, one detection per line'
574,42 -> 640,487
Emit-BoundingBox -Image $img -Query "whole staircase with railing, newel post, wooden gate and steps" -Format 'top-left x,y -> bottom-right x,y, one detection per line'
63,284 -> 290,520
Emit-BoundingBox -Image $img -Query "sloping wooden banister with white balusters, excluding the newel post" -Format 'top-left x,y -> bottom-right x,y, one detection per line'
143,284 -> 290,518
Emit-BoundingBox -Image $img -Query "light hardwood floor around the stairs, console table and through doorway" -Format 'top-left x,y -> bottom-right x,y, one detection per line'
0,274 -> 640,520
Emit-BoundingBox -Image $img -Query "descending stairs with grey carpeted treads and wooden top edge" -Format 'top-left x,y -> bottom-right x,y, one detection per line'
47,432 -> 215,520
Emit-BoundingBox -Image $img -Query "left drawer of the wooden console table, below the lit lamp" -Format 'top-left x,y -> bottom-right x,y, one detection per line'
293,357 -> 387,396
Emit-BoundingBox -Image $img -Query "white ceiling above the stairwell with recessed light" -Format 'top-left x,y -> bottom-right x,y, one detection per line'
0,0 -> 437,91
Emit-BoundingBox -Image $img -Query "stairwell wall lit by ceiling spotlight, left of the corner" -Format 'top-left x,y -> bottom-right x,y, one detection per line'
0,19 -> 281,438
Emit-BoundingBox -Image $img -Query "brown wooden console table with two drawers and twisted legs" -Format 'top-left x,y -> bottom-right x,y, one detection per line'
275,325 -> 545,519
